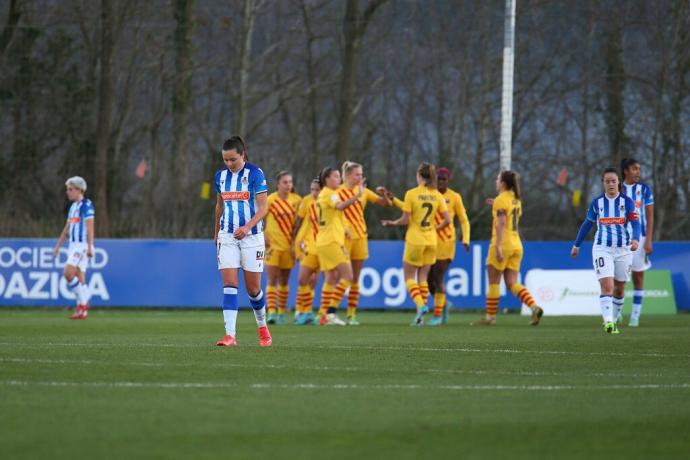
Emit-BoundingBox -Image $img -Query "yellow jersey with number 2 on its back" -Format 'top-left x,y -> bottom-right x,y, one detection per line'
402,185 -> 448,246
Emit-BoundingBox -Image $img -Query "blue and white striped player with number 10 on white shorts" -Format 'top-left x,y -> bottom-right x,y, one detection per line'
570,168 -> 640,334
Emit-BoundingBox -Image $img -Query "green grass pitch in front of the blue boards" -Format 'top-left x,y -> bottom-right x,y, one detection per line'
0,309 -> 690,459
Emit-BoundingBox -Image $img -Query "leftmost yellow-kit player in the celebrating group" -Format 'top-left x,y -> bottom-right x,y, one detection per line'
264,171 -> 301,324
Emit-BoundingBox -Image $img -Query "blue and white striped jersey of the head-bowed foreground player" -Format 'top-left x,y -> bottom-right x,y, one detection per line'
215,163 -> 268,235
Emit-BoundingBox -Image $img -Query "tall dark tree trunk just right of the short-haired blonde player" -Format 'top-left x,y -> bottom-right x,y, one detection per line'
95,0 -> 115,237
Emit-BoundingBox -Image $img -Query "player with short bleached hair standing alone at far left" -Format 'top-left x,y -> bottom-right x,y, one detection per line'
53,176 -> 96,319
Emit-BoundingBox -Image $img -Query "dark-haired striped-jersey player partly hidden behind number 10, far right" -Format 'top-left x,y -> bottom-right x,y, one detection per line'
621,158 -> 654,327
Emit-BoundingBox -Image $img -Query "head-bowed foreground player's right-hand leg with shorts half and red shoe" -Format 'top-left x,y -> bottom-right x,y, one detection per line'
239,234 -> 273,347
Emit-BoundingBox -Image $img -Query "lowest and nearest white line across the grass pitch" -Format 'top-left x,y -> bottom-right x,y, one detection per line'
0,380 -> 690,391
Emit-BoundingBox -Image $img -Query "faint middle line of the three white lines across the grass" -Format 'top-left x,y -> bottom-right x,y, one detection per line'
0,358 -> 664,378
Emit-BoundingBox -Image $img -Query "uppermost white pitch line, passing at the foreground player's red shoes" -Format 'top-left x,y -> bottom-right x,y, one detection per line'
0,342 -> 690,358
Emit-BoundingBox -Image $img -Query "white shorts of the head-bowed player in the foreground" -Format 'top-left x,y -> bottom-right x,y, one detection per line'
216,233 -> 265,273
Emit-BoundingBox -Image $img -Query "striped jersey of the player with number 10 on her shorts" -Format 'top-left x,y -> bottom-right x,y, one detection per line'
587,194 -> 639,247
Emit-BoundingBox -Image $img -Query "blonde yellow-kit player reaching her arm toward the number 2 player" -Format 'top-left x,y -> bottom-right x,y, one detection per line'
338,161 -> 391,326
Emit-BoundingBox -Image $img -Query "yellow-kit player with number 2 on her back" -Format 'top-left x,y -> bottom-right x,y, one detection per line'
381,163 -> 450,326
